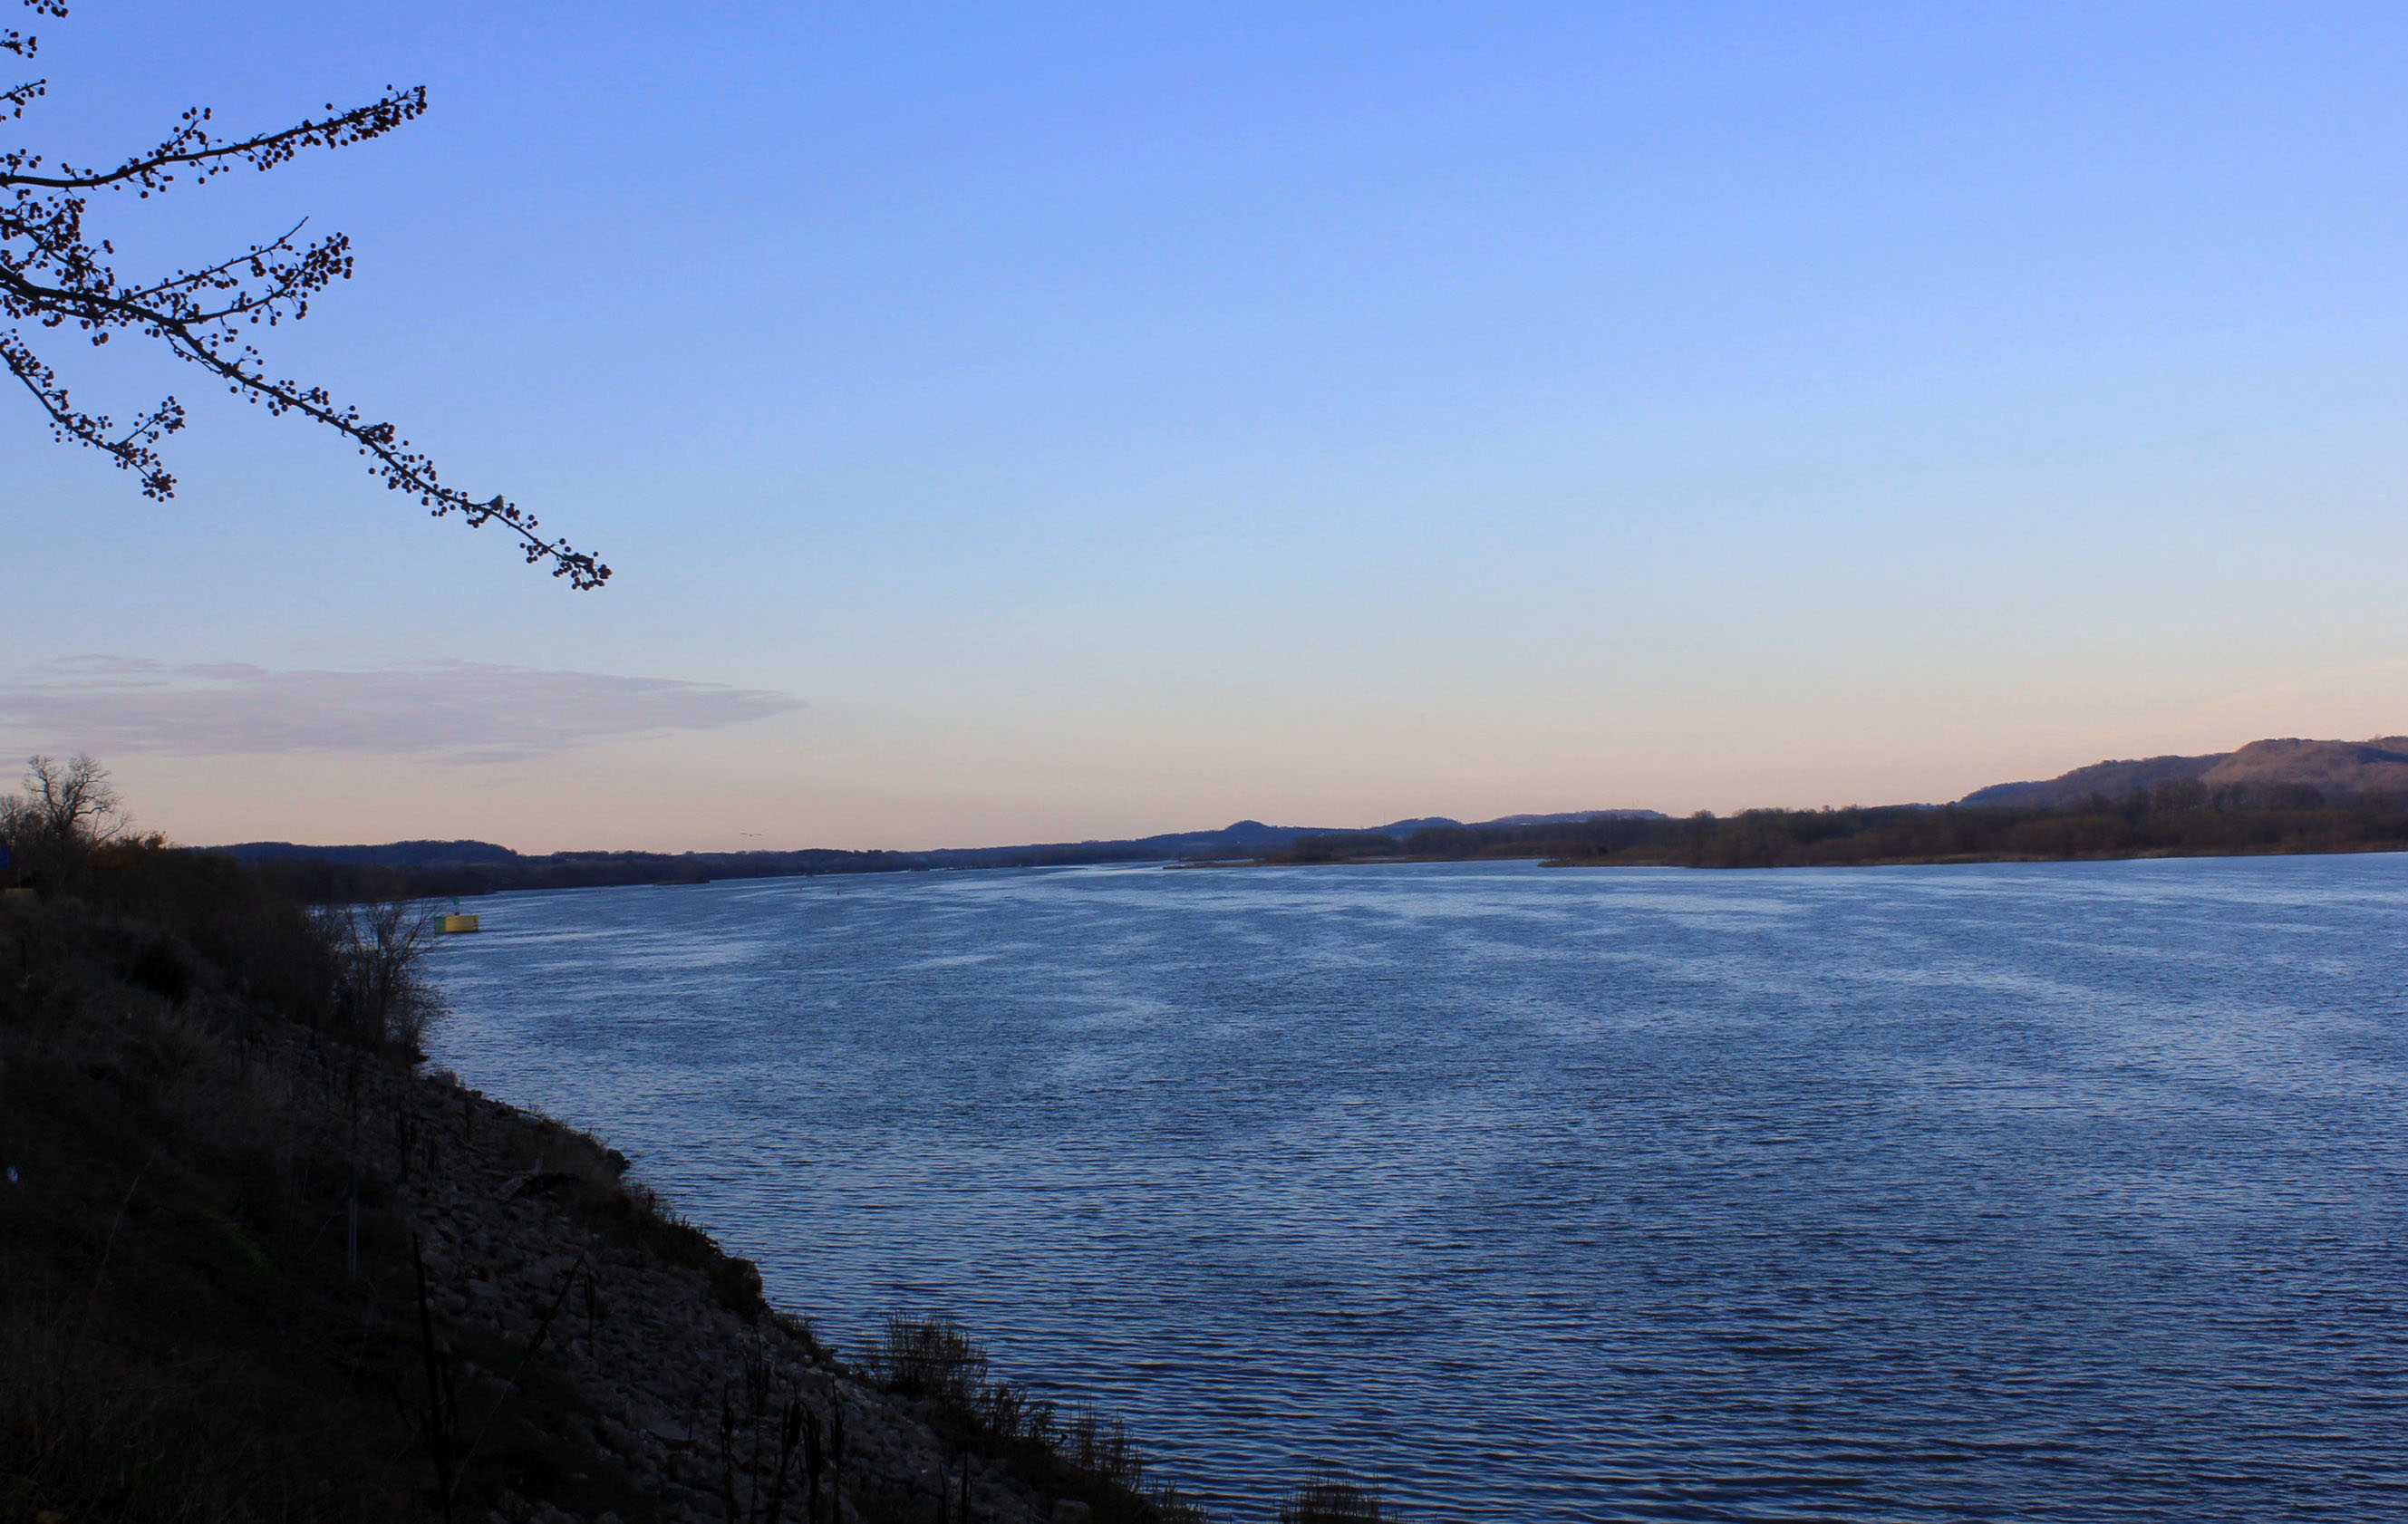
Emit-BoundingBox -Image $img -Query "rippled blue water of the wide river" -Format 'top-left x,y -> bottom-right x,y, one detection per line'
436,857 -> 2408,1521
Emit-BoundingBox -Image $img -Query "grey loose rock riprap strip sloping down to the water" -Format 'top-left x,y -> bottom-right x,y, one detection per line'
342,1039 -> 1156,1524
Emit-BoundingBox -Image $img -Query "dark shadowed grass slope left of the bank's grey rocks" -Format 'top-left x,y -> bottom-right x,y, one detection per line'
0,908 -> 414,1524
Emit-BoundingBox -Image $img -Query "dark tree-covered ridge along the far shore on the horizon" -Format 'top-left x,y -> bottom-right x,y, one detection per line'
192,737 -> 2408,902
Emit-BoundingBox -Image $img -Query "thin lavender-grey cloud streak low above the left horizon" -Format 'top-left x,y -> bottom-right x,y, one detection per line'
0,657 -> 802,763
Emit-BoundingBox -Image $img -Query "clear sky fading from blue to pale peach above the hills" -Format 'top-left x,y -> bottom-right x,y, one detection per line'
0,0 -> 2408,847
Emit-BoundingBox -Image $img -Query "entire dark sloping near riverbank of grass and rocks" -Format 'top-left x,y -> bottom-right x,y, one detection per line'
0,902 -> 1187,1524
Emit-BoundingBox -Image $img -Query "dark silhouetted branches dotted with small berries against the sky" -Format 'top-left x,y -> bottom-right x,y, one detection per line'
0,0 -> 609,590
